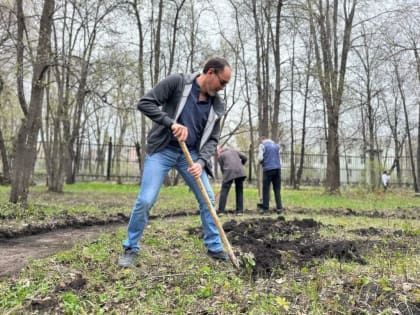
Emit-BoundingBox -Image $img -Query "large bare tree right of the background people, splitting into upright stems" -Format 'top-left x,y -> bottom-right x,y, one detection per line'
307,0 -> 357,193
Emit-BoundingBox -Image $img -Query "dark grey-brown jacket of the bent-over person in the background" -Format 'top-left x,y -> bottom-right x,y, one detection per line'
218,149 -> 248,183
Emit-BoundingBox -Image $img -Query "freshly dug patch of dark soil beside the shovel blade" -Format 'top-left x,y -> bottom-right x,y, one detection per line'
189,216 -> 412,278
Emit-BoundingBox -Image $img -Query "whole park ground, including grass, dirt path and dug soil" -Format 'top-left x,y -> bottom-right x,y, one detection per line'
0,183 -> 420,314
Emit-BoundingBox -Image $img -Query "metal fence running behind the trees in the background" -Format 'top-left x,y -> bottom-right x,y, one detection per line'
22,141 -> 412,186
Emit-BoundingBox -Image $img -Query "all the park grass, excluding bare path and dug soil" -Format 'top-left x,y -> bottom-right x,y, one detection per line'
0,183 -> 420,314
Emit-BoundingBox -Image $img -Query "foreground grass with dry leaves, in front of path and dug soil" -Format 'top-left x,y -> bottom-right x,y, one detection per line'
0,218 -> 420,314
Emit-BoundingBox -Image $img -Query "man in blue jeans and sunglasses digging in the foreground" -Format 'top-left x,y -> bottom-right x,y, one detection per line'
118,57 -> 231,267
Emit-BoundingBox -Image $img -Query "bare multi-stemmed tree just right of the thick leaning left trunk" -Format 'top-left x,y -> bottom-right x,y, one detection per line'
44,1 -> 119,191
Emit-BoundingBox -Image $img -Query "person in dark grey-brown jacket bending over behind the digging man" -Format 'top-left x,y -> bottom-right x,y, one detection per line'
217,147 -> 247,216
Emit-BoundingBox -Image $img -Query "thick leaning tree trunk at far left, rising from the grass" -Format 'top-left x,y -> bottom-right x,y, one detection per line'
10,0 -> 55,203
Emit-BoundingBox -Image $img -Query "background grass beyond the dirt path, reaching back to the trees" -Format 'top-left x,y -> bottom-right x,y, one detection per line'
0,182 -> 420,233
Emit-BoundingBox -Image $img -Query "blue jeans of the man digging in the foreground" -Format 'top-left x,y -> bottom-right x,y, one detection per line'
123,146 -> 223,252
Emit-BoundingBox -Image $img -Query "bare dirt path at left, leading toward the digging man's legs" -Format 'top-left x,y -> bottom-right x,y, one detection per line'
0,223 -> 127,280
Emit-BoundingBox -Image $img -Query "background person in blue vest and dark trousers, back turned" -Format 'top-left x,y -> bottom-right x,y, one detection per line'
258,136 -> 283,214
